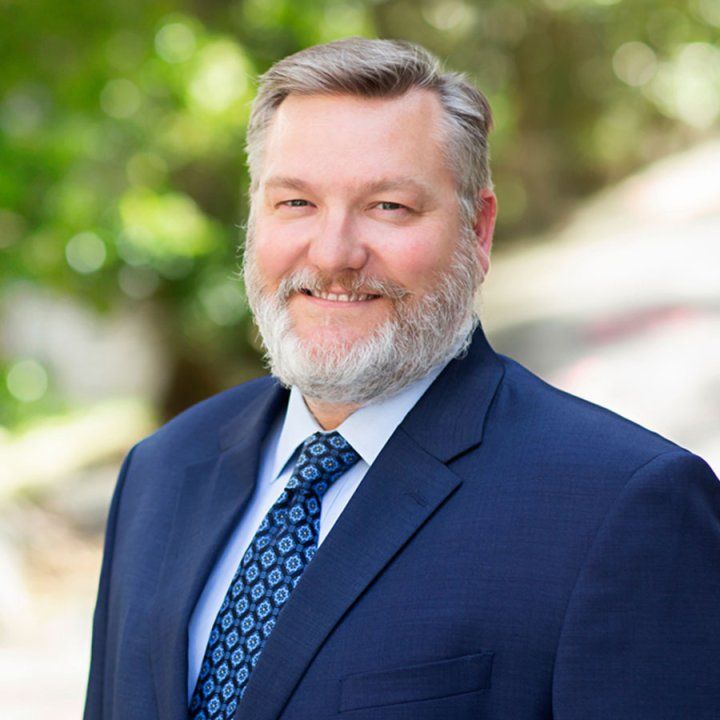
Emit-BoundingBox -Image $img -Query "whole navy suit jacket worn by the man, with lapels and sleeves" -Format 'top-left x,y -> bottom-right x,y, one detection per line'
85,331 -> 720,720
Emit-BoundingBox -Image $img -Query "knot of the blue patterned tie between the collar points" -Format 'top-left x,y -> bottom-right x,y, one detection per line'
294,431 -> 360,500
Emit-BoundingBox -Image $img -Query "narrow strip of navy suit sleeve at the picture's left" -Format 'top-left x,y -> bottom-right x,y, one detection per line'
83,448 -> 134,720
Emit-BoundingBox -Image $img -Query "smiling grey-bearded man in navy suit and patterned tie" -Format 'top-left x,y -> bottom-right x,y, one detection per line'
85,39 -> 720,720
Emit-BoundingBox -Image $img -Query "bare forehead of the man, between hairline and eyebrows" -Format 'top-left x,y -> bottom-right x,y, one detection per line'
260,89 -> 453,193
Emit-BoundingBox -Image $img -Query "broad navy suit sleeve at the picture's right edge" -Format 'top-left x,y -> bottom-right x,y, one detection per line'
553,450 -> 720,720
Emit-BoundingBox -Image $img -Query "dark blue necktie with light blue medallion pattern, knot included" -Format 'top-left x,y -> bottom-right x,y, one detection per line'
190,432 -> 360,720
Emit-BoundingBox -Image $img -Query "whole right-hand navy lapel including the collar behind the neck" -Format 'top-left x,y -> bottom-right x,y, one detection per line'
236,330 -> 502,720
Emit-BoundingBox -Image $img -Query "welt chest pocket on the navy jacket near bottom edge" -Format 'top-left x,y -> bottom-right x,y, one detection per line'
340,652 -> 493,713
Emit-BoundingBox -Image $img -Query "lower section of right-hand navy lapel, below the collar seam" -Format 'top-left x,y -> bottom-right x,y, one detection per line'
236,432 -> 460,720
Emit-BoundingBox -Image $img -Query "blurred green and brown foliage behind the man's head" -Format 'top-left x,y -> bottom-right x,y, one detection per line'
0,0 -> 720,425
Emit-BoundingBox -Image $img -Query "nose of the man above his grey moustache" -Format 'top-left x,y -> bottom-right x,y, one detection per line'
307,211 -> 368,276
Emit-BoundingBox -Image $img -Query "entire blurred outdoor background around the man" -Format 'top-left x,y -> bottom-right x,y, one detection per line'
0,0 -> 720,720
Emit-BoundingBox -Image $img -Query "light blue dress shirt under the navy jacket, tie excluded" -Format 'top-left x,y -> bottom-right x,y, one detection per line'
188,366 -> 444,701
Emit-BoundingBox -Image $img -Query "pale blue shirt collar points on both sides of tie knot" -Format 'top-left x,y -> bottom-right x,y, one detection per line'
271,365 -> 445,482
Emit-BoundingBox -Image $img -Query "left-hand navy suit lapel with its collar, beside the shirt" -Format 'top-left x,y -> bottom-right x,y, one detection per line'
151,384 -> 287,718
